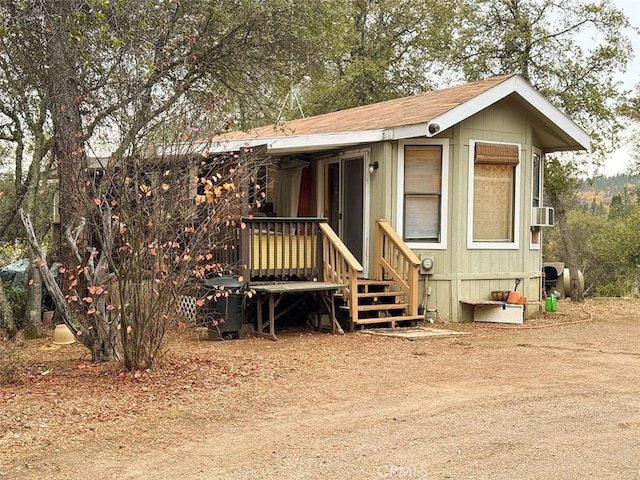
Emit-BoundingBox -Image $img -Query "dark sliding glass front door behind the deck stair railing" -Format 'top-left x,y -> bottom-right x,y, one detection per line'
323,156 -> 365,266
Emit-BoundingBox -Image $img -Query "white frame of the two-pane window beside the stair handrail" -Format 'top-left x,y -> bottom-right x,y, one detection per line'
396,138 -> 449,250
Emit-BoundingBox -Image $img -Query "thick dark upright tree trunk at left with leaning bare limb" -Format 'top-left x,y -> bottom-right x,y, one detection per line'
41,1 -> 117,362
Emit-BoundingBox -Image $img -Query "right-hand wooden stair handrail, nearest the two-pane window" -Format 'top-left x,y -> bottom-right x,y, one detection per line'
375,218 -> 420,315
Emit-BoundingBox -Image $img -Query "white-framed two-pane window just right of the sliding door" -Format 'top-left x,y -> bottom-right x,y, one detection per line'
398,141 -> 448,249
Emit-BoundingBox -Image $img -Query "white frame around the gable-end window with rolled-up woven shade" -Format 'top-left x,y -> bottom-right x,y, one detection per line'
467,140 -> 522,250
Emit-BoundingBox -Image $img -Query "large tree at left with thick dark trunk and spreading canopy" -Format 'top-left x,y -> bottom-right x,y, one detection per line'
0,0 -> 336,368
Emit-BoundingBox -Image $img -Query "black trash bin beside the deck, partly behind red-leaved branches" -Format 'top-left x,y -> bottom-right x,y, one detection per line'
203,276 -> 244,340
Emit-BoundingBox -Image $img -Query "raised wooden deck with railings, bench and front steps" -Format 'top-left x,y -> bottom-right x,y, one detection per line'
208,217 -> 422,338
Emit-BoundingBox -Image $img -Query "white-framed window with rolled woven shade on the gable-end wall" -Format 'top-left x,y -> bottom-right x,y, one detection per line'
469,142 -> 520,248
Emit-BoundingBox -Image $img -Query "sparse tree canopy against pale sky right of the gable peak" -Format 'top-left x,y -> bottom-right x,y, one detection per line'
451,0 -> 632,162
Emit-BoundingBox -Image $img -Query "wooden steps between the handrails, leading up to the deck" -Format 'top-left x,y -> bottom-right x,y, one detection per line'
340,278 -> 423,331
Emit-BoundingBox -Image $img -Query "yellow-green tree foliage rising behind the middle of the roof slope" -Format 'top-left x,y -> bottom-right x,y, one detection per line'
304,0 -> 462,114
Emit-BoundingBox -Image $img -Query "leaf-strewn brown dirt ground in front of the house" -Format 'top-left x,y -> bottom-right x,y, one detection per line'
0,299 -> 640,480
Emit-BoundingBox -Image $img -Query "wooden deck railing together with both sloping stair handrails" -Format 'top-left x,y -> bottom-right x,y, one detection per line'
212,217 -> 420,323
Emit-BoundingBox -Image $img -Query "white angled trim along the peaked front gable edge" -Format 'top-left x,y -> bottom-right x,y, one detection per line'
424,76 -> 591,150
